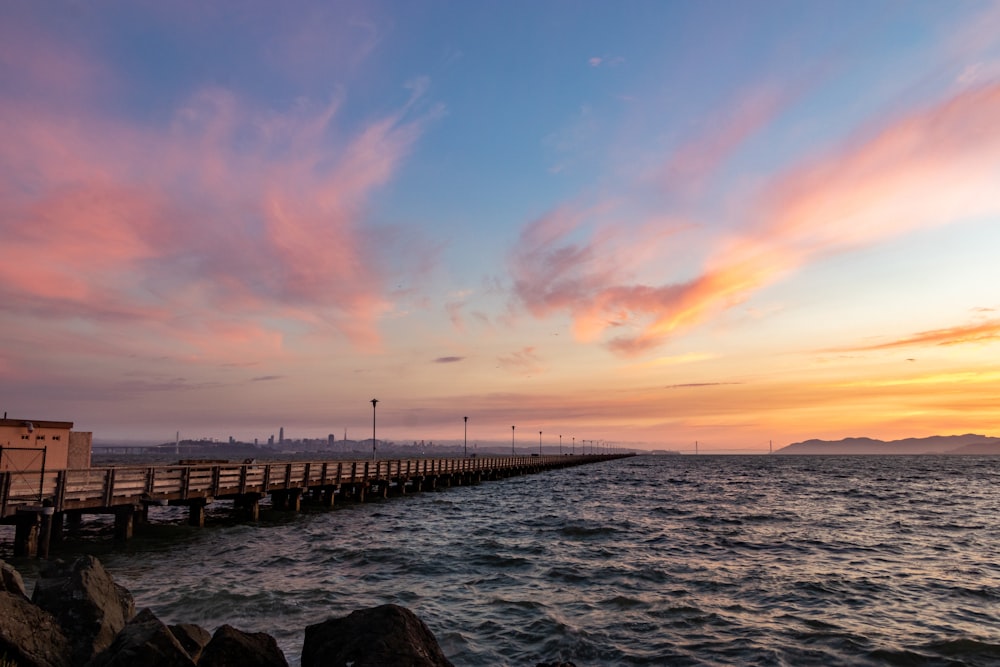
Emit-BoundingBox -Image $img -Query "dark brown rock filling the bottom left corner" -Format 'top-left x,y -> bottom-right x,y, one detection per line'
0,591 -> 73,667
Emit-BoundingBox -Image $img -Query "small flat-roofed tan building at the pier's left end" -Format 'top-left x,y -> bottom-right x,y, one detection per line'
0,416 -> 93,472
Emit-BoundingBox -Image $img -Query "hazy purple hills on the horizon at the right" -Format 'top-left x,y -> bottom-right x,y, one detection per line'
774,433 -> 1000,455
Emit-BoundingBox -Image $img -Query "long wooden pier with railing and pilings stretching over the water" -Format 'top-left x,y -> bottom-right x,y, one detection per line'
0,454 -> 632,558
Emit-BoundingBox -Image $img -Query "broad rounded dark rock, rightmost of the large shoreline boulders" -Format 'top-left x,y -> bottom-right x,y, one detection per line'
302,604 -> 453,667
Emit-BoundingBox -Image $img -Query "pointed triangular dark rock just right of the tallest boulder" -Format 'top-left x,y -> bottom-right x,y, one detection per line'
88,609 -> 195,667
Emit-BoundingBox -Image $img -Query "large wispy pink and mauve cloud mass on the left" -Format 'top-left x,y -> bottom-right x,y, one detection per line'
0,43 -> 430,358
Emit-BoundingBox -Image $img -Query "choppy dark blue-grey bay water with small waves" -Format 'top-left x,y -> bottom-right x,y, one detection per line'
11,456 -> 1000,667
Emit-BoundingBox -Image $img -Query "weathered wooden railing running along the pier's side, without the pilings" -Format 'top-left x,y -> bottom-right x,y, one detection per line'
0,454 -> 621,520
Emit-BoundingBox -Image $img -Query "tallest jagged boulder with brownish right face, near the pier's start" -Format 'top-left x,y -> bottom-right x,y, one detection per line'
31,556 -> 135,665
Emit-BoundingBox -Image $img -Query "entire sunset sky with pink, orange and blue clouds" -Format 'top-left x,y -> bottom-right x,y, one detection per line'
0,0 -> 1000,452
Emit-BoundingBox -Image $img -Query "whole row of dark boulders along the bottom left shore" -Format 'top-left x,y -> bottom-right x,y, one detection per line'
0,556 -> 573,667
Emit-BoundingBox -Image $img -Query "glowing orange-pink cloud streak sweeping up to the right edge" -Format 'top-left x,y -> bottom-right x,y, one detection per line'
511,84 -> 1000,354
